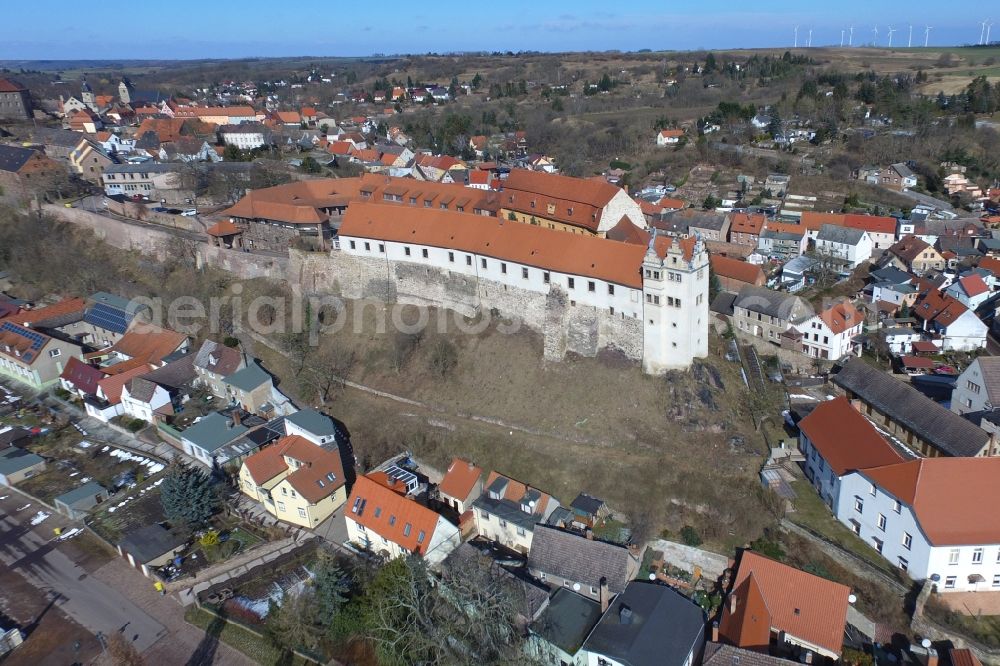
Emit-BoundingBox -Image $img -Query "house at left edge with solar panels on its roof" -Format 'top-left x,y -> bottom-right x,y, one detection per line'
0,321 -> 82,389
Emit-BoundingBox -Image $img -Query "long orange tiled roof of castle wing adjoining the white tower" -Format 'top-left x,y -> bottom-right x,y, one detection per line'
339,203 -> 695,289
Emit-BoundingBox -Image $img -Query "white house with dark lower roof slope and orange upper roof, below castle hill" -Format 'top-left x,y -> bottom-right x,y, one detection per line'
472,472 -> 559,553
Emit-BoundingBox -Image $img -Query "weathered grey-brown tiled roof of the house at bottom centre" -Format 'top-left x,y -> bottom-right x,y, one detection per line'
528,525 -> 635,594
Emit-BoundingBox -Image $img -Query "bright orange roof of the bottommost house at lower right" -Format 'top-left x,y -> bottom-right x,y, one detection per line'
724,550 -> 851,655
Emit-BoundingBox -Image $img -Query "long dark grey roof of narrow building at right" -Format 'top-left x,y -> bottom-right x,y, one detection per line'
833,358 -> 990,456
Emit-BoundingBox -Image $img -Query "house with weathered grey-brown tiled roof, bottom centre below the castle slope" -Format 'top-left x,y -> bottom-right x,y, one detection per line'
527,525 -> 639,602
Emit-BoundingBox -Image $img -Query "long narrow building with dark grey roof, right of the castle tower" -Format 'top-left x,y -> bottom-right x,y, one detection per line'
832,359 -> 1000,458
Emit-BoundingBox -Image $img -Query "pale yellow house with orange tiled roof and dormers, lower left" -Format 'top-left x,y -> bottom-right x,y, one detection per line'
240,435 -> 347,529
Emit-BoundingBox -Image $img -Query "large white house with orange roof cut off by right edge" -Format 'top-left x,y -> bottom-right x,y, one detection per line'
836,458 -> 1000,592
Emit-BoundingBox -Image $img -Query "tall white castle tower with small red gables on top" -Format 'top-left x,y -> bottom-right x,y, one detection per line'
642,230 -> 709,374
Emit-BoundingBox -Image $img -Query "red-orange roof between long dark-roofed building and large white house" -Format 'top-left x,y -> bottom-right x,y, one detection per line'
799,396 -> 905,476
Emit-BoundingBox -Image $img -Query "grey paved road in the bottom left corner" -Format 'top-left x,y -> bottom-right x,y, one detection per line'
0,487 -> 167,652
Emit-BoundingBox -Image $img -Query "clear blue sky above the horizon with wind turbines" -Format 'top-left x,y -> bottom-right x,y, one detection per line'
0,0 -> 1000,59
